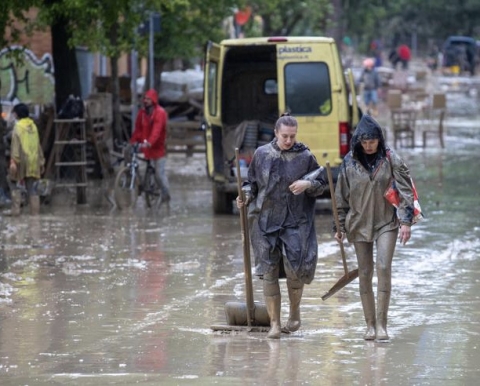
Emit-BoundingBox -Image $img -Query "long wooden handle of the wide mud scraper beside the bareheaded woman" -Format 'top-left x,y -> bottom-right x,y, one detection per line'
235,148 -> 255,327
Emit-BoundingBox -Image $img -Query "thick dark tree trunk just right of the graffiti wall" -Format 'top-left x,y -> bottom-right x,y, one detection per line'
50,18 -> 82,112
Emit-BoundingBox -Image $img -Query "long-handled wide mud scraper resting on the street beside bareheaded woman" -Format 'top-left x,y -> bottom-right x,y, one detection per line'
211,148 -> 270,332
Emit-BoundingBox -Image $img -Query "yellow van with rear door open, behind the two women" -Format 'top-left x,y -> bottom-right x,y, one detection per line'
204,37 -> 358,213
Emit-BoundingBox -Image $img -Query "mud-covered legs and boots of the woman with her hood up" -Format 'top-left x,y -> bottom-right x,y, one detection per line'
354,229 -> 398,341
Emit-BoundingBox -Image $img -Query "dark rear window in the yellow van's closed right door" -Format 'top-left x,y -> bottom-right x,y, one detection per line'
285,62 -> 332,115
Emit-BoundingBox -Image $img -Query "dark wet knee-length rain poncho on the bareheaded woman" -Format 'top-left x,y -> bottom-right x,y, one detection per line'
243,139 -> 326,284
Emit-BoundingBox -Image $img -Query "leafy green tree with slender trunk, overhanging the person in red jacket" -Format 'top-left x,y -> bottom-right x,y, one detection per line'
40,0 -> 238,137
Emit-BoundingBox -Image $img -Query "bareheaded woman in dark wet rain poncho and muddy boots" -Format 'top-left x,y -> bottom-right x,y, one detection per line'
237,115 -> 326,339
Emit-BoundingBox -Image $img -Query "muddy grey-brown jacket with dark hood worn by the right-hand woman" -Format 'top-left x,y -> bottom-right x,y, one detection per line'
335,114 -> 414,242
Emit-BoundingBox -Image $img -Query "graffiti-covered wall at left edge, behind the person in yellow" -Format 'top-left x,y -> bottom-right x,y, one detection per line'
0,46 -> 55,105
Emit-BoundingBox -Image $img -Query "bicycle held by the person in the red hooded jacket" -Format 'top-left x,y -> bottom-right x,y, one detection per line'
113,143 -> 162,209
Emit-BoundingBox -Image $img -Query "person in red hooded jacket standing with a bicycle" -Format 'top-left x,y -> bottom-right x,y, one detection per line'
130,89 -> 170,202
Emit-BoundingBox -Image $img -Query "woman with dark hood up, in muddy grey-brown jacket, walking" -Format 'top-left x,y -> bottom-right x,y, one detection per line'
334,115 -> 414,341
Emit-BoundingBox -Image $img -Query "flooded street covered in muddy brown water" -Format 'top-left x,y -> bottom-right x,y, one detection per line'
0,85 -> 480,386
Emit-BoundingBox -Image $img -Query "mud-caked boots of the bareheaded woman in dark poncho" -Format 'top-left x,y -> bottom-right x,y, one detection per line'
263,267 -> 303,339
